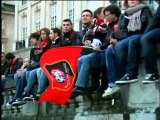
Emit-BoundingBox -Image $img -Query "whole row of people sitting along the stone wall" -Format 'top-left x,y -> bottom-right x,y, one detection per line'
1,0 -> 160,106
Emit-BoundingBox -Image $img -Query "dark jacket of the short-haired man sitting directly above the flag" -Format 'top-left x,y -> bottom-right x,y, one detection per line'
62,30 -> 82,46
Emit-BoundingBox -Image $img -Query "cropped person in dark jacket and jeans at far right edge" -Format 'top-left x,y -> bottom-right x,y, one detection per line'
141,0 -> 160,84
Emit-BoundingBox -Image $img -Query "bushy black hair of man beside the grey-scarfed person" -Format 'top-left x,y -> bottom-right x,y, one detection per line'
103,5 -> 121,17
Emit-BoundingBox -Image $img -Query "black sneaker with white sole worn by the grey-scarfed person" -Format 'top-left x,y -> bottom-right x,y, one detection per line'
115,74 -> 138,84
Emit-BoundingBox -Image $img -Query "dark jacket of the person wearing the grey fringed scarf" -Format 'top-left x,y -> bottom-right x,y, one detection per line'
114,7 -> 152,41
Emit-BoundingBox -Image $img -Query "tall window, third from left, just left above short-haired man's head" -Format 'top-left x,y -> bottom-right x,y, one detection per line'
50,3 -> 57,28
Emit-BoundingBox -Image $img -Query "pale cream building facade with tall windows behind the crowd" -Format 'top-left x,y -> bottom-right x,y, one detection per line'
12,0 -> 159,54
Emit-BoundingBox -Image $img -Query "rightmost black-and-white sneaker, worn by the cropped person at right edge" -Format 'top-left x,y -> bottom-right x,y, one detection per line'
142,74 -> 159,84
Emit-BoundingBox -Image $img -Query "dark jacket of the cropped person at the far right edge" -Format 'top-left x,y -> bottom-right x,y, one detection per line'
145,6 -> 160,32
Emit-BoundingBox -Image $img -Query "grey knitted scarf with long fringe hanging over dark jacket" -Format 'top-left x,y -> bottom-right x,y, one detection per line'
125,4 -> 147,32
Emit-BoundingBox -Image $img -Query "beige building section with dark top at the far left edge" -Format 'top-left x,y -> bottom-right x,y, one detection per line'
1,1 -> 15,52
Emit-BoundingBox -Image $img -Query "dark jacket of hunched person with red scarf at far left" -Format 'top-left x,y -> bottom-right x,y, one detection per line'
5,58 -> 23,77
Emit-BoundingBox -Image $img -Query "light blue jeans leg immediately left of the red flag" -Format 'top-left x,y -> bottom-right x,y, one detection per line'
37,68 -> 48,94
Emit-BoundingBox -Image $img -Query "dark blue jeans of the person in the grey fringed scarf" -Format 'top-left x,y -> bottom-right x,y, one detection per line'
115,34 -> 142,77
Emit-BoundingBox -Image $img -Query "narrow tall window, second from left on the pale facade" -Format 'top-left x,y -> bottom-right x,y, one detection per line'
35,10 -> 41,31
